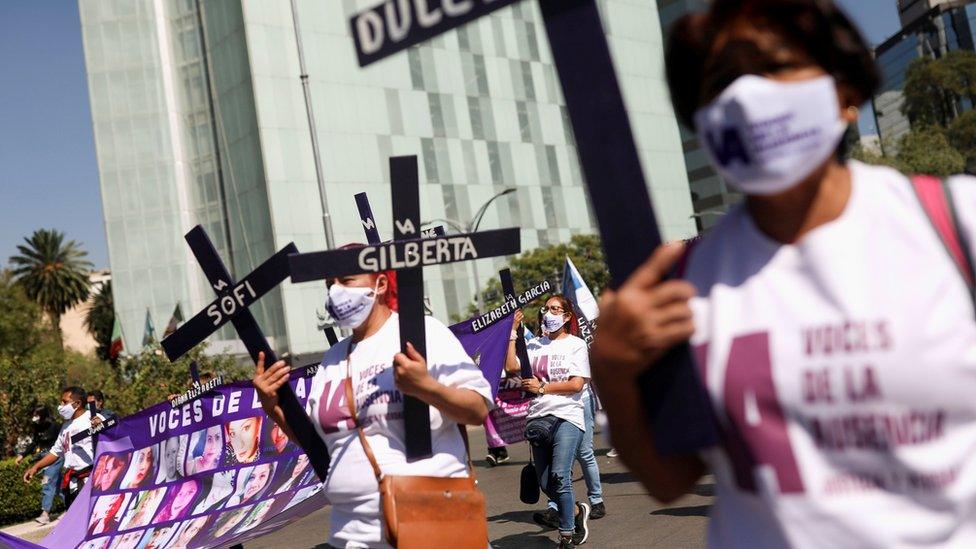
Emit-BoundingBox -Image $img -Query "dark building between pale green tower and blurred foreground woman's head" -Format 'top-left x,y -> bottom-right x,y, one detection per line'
657,0 -> 742,230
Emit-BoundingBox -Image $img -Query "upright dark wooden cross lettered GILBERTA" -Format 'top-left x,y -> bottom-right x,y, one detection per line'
289,156 -> 521,460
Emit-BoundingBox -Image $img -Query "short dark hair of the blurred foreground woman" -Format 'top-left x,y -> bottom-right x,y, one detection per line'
665,0 -> 881,128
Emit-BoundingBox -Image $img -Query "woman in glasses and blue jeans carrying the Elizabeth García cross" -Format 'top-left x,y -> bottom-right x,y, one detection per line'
505,295 -> 603,547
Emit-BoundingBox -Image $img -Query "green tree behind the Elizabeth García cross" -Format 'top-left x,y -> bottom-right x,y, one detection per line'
454,235 -> 610,326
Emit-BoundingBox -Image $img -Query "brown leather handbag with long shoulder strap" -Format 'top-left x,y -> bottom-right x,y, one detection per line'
345,359 -> 488,549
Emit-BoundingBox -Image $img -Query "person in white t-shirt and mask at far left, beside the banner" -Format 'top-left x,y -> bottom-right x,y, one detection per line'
24,386 -> 104,507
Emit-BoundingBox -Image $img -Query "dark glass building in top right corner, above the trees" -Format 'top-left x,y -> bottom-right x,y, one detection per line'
873,2 -> 976,146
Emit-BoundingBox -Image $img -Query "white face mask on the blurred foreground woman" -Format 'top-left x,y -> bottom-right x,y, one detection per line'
695,75 -> 847,195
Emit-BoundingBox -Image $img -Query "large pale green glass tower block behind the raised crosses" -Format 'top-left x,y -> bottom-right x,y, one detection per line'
79,0 -> 696,354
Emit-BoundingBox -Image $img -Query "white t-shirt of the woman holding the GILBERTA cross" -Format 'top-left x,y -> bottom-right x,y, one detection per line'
307,313 -> 494,548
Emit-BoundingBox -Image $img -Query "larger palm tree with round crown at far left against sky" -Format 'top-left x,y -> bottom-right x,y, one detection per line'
10,229 -> 92,341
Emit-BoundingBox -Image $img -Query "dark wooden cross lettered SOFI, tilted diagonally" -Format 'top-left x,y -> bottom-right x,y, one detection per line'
162,225 -> 329,481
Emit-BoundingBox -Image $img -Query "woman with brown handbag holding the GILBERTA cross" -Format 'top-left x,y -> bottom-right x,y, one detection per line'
254,246 -> 493,548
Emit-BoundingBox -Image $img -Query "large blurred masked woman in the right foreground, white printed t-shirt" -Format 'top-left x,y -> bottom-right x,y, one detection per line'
592,0 -> 976,547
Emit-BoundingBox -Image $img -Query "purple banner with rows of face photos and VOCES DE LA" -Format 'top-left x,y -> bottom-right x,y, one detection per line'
8,367 -> 327,549
